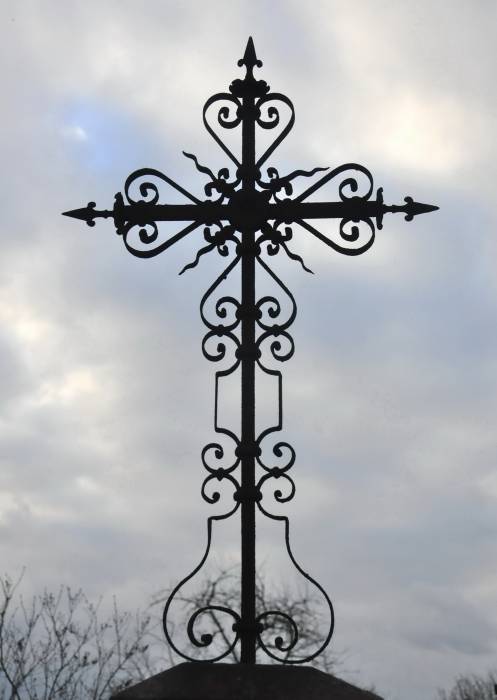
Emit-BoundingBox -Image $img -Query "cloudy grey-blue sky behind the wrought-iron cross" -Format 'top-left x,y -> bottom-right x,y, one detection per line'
0,0 -> 497,700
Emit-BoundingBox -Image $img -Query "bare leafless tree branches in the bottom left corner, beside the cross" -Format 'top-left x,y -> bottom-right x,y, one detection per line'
0,576 -> 155,700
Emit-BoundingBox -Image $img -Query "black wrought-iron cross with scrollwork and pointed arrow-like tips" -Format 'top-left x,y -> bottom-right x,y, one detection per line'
64,38 -> 438,663
